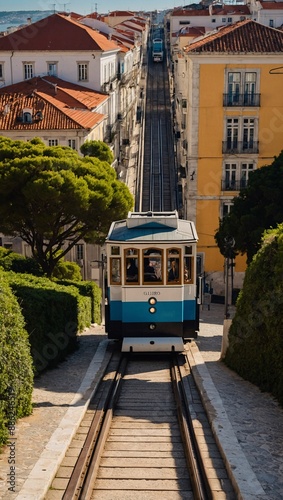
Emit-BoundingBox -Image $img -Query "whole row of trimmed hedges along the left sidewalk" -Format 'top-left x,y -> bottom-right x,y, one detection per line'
0,251 -> 101,446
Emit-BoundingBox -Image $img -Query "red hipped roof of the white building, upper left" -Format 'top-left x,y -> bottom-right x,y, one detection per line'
0,14 -> 118,51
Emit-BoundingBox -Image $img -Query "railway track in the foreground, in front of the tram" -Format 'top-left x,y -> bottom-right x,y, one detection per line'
47,346 -> 235,500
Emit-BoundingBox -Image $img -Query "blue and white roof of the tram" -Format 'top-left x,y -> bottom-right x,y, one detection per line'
106,211 -> 198,243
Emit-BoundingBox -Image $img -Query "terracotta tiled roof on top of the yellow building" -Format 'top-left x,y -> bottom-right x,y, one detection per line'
184,19 -> 283,53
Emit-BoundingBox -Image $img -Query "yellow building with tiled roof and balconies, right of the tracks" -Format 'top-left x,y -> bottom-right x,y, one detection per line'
174,20 -> 283,294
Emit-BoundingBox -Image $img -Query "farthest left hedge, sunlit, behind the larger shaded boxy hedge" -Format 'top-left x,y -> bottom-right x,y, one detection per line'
56,280 -> 102,325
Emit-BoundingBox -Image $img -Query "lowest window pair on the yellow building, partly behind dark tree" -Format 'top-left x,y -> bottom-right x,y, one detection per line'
222,162 -> 256,191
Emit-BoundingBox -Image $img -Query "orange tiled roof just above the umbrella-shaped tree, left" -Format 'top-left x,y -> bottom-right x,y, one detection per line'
0,77 -> 108,131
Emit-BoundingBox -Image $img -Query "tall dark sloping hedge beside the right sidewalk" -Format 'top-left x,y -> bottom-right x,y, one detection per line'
225,224 -> 283,406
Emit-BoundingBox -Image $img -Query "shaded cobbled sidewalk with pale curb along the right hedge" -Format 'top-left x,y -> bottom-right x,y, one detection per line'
195,304 -> 283,500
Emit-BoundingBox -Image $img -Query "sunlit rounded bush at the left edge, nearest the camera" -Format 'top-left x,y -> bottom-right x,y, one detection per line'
0,272 -> 33,445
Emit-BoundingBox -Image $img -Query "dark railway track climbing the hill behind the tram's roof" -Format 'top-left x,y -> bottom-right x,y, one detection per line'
140,46 -> 178,212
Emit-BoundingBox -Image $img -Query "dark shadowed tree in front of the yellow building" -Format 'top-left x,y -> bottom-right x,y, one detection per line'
215,151 -> 283,263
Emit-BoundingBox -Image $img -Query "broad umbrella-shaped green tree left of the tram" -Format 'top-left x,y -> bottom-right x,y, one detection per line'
0,138 -> 133,277
